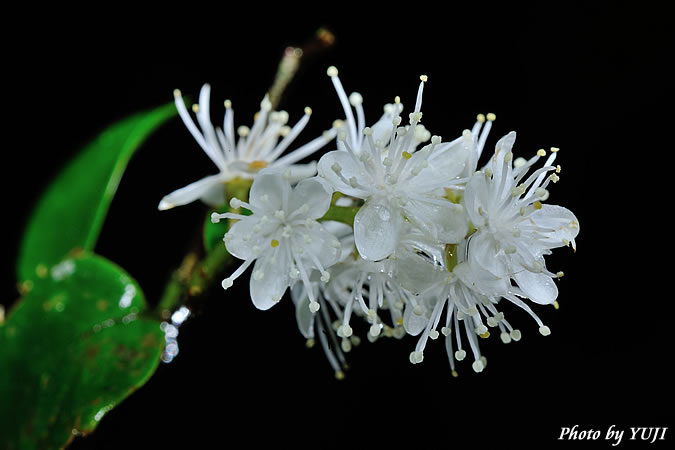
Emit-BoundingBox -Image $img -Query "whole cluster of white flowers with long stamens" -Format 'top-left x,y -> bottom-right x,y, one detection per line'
159,67 -> 579,377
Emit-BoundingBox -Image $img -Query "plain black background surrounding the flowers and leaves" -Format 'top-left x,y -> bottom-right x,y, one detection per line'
2,2 -> 673,449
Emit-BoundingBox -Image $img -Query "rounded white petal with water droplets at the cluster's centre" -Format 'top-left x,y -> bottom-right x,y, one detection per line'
354,202 -> 403,261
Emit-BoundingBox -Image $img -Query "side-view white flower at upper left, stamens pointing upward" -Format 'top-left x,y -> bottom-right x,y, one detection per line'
158,84 -> 336,210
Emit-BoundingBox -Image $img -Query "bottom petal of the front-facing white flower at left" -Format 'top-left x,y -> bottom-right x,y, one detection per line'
249,252 -> 290,310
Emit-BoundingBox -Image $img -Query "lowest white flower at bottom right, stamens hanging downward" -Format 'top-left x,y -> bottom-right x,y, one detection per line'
397,236 -> 550,376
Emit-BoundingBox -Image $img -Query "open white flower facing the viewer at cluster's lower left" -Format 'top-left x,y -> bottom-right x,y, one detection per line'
212,169 -> 341,312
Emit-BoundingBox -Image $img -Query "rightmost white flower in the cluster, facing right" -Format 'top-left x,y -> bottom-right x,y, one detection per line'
464,132 -> 579,304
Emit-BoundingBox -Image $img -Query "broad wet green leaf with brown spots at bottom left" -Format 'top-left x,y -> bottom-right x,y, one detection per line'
0,252 -> 164,450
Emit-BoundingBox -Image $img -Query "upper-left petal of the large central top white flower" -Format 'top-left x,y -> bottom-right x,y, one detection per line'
318,150 -> 372,199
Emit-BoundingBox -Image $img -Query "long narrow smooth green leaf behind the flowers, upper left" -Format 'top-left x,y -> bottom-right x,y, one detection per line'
17,103 -> 176,281
